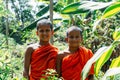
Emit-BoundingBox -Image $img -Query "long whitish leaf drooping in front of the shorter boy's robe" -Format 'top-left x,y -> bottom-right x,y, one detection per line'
82,46 -> 109,80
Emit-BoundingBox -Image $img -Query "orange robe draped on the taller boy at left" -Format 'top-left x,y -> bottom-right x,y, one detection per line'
30,44 -> 58,80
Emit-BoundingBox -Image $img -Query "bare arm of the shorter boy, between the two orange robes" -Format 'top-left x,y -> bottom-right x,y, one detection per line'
56,54 -> 62,77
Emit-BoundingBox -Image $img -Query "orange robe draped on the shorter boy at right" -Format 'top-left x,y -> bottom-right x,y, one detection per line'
61,47 -> 94,80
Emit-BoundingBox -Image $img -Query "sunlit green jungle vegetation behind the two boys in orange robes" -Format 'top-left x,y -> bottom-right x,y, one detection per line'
0,0 -> 120,80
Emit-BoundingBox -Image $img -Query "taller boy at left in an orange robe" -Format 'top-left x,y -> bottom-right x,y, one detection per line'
23,19 -> 58,80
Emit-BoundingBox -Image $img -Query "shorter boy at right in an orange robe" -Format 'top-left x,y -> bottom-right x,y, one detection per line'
56,26 -> 94,80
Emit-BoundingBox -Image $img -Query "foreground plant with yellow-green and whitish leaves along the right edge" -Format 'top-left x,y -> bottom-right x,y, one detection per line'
82,2 -> 120,80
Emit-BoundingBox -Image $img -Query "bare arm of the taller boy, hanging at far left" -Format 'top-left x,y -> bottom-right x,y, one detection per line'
23,47 -> 33,79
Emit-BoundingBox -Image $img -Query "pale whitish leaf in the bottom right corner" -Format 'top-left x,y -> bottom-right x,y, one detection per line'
101,67 -> 120,80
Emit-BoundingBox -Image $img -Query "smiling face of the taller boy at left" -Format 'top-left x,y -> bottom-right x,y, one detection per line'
37,25 -> 53,41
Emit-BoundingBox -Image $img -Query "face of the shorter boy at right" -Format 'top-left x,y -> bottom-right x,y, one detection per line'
66,30 -> 82,47
